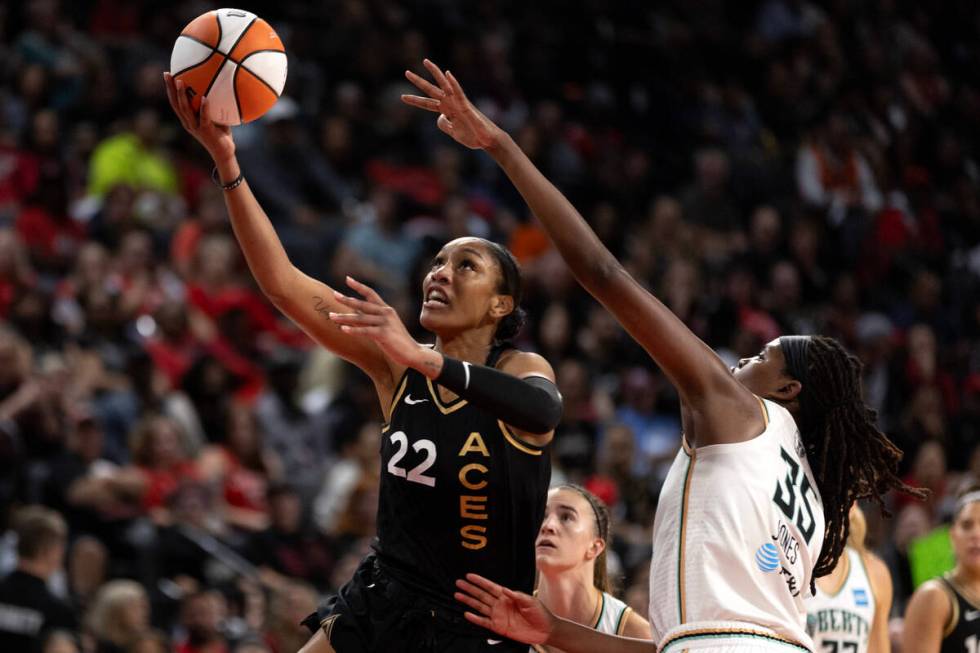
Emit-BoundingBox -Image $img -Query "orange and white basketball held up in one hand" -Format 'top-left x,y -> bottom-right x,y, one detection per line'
170,9 -> 286,125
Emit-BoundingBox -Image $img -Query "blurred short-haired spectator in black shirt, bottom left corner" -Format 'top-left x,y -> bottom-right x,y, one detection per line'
0,506 -> 78,653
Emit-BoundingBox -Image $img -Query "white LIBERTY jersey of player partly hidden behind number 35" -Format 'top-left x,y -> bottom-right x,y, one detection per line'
806,547 -> 875,653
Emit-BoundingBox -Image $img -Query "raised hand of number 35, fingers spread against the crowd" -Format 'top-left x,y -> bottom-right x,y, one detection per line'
402,59 -> 503,150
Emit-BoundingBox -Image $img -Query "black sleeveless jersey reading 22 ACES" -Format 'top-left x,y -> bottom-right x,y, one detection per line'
374,354 -> 551,610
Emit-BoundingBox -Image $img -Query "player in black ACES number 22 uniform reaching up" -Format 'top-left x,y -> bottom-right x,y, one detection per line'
165,75 -> 561,653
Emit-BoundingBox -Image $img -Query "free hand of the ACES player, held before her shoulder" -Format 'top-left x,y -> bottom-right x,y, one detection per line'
328,277 -> 421,367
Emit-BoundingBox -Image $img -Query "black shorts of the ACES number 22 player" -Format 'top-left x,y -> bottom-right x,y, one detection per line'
303,554 -> 529,653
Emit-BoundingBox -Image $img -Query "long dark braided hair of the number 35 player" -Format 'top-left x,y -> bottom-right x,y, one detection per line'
780,336 -> 927,578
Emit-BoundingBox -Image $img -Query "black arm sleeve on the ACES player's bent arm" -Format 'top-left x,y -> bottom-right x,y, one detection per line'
435,356 -> 561,434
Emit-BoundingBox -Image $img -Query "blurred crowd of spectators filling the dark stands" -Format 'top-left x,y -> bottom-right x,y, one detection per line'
0,0 -> 980,653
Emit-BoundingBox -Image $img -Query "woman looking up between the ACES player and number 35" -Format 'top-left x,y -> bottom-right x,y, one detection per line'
532,485 -> 651,653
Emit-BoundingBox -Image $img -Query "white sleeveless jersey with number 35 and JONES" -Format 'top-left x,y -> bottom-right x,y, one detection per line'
650,399 -> 824,652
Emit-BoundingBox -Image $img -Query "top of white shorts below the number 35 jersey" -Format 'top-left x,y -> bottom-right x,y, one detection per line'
657,622 -> 812,653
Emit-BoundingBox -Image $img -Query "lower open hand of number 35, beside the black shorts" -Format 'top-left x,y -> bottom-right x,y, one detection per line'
453,574 -> 555,644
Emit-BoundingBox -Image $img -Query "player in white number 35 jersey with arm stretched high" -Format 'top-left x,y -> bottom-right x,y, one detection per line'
403,60 -> 928,653
